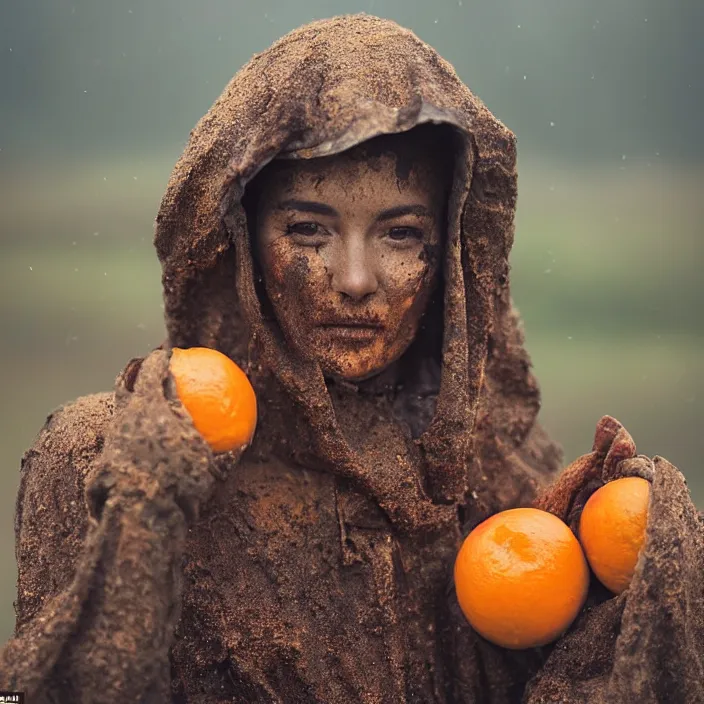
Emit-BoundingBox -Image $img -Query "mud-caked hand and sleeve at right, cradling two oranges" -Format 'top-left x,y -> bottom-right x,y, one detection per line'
523,416 -> 704,704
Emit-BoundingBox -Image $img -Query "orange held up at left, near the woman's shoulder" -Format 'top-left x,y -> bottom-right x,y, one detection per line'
169,347 -> 257,452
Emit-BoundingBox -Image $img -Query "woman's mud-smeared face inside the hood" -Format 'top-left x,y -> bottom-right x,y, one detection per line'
255,138 -> 447,381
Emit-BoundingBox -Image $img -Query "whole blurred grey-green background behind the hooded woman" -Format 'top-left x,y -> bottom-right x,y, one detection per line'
0,0 -> 704,641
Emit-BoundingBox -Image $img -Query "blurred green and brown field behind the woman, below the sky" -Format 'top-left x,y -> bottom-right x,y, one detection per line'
0,155 -> 704,641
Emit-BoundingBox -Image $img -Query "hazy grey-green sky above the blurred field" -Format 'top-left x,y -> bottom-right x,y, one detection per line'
0,0 -> 704,167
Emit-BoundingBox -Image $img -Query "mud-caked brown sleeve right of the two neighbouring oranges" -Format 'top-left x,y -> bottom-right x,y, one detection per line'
524,457 -> 704,704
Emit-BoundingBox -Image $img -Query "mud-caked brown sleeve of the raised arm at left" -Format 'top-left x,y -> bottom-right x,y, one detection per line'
0,353 -> 219,704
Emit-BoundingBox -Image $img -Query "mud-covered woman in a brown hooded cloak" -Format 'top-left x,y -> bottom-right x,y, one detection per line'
0,15 -> 704,704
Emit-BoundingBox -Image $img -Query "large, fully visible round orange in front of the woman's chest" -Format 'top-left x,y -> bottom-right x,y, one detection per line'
455,508 -> 589,650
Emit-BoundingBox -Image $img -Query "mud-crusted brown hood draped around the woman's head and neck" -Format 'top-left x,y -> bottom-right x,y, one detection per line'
155,15 -> 559,529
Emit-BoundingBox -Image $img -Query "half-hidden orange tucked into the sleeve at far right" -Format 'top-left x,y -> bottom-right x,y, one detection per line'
579,477 -> 650,594
